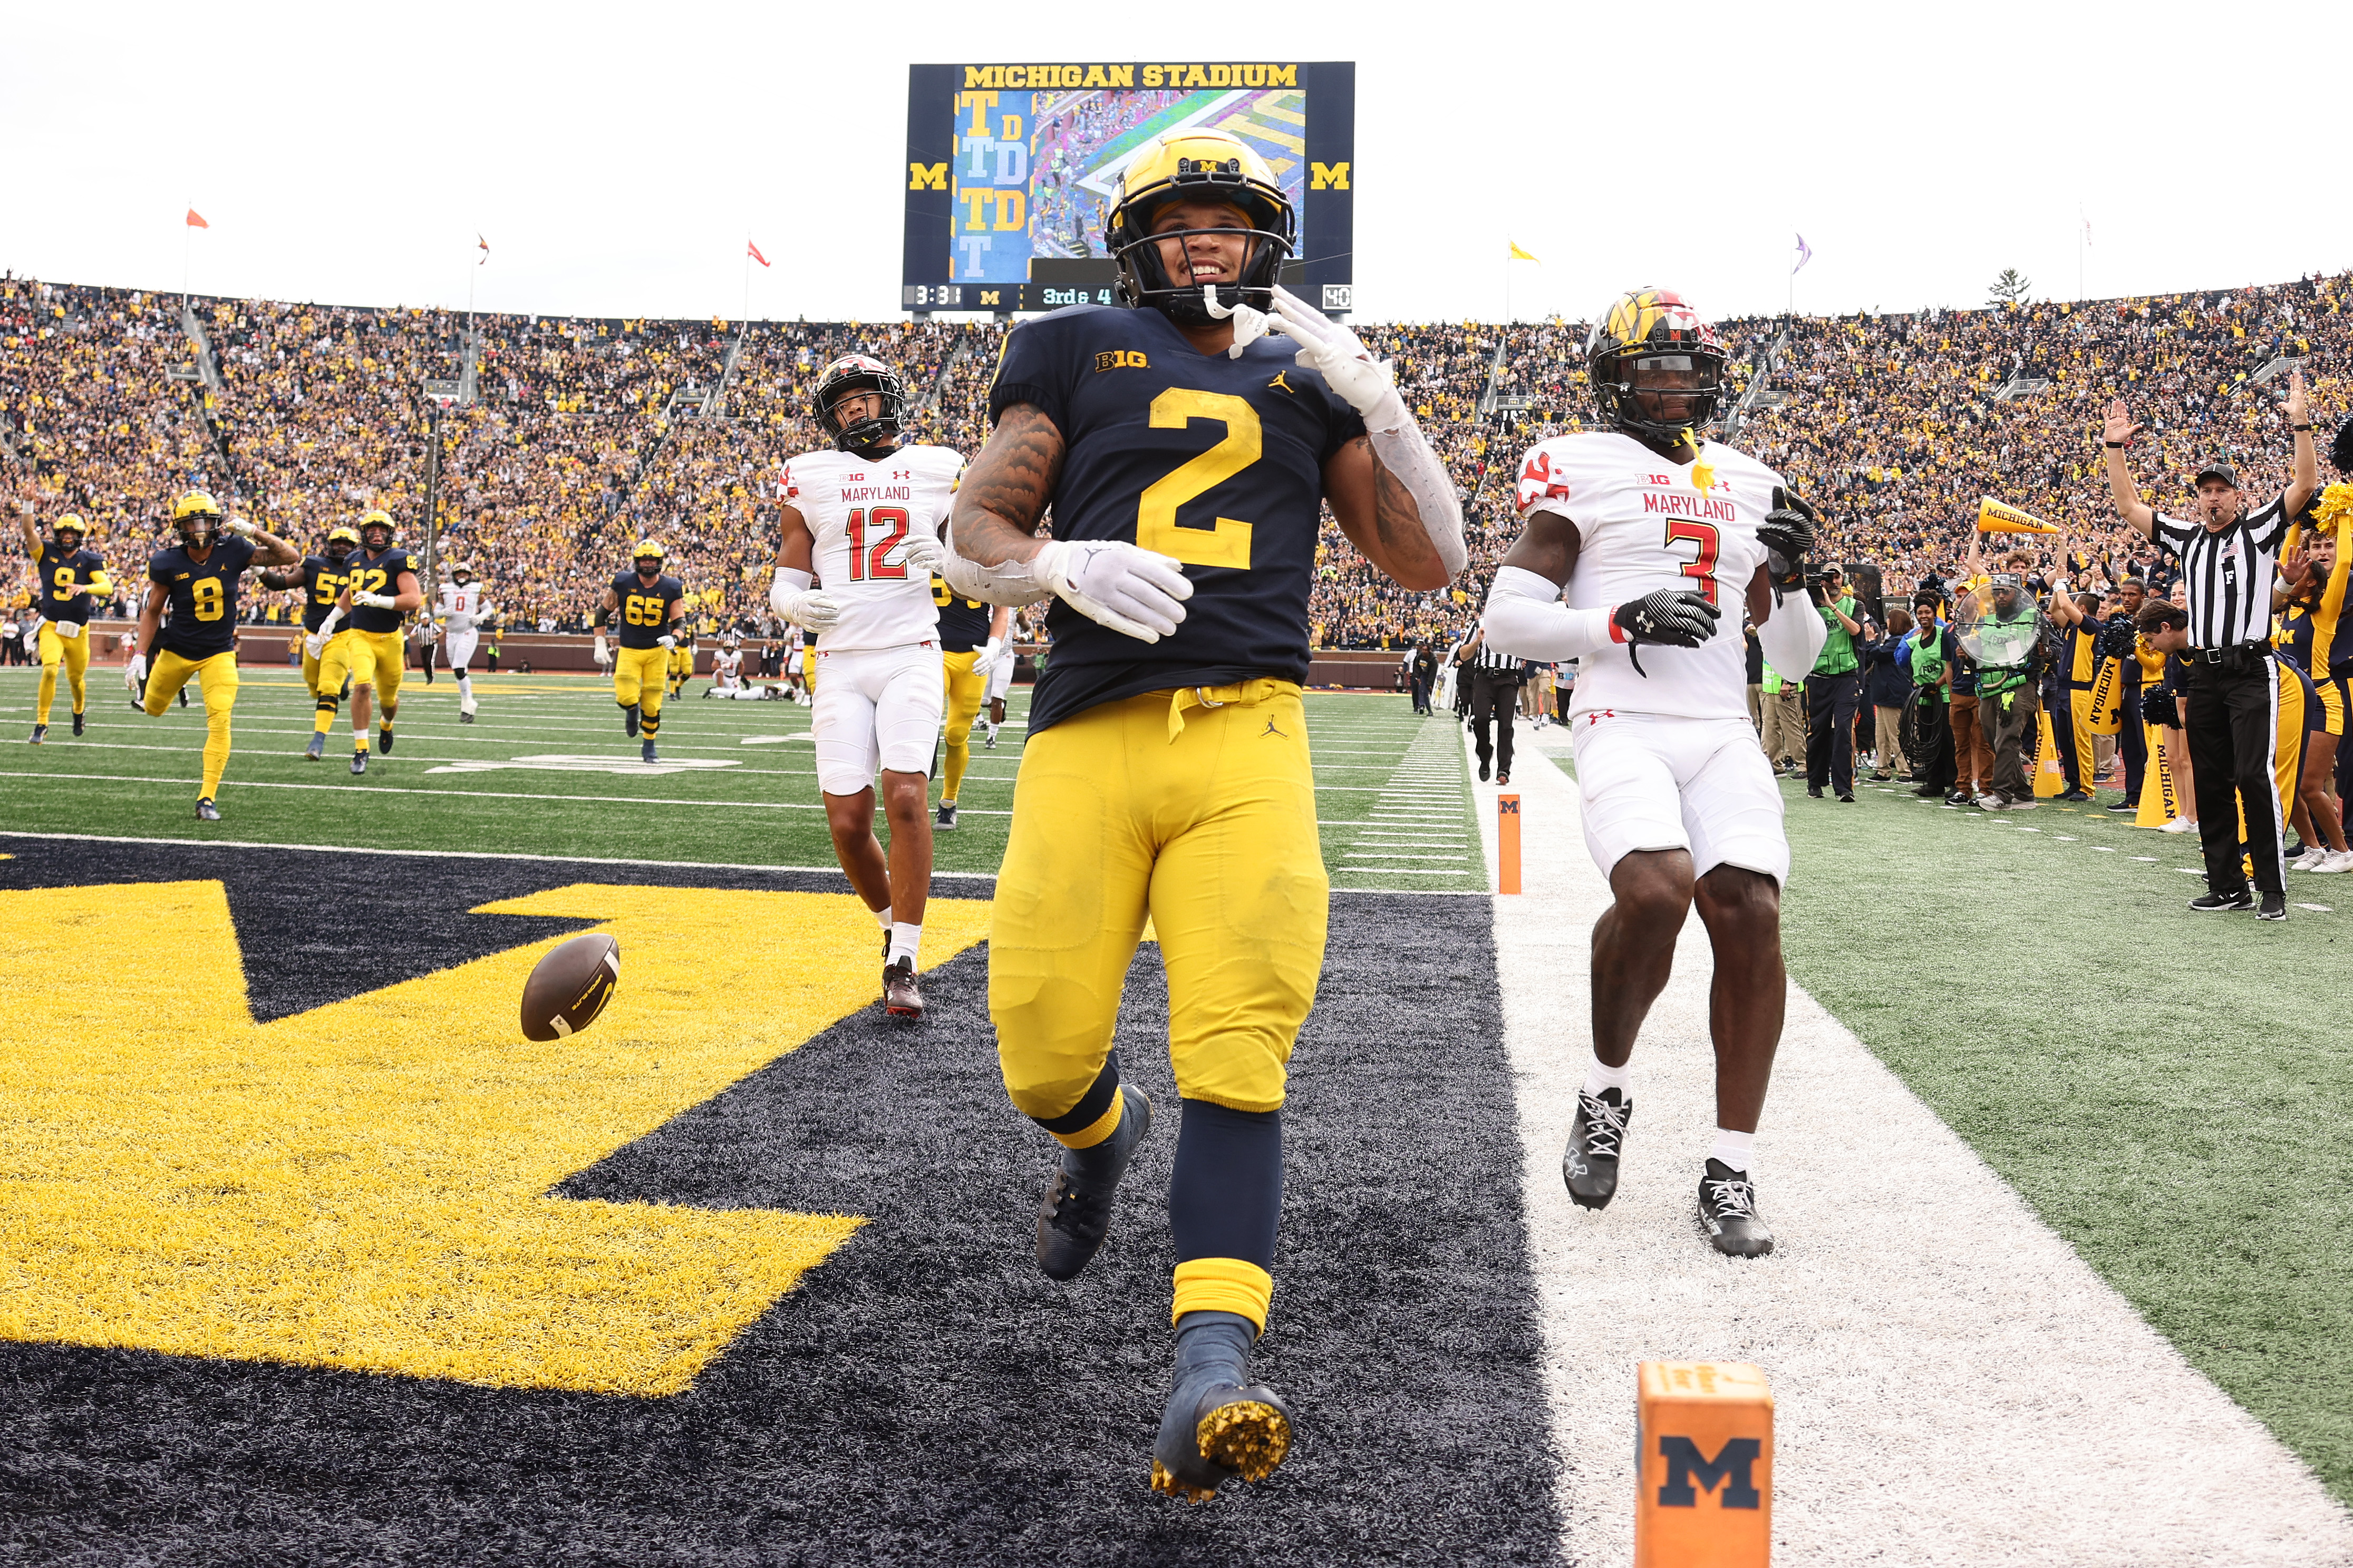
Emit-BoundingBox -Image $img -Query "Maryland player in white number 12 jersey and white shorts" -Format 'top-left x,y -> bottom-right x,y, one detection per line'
769,355 -> 965,1018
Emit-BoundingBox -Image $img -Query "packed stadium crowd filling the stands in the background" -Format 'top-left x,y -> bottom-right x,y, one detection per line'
0,275 -> 2353,649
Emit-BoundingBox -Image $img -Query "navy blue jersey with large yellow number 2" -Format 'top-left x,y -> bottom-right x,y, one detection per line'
988,306 -> 1365,736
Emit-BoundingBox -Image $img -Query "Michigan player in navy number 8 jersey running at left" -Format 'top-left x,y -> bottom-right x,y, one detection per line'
139,489 -> 301,823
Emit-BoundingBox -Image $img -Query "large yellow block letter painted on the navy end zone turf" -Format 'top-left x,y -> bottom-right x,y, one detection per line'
0,882 -> 988,1394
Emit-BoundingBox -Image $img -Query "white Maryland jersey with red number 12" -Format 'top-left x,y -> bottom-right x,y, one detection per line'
783,446 -> 965,654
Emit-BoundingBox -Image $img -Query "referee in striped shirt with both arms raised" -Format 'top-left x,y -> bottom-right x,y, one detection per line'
2104,369 -> 2320,919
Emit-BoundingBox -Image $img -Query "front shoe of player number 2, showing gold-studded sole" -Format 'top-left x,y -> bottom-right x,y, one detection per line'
1153,1312 -> 1292,1502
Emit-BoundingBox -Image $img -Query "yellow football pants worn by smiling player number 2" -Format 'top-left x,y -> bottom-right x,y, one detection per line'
988,679 -> 1330,1124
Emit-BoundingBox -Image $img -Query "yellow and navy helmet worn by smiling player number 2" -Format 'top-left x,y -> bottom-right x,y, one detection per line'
1103,127 -> 1299,327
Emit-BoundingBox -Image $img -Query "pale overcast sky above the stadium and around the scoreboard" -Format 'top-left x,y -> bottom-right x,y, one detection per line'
0,0 -> 2353,320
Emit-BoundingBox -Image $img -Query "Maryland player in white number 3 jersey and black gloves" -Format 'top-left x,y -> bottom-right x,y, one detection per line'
1485,289 -> 1828,1258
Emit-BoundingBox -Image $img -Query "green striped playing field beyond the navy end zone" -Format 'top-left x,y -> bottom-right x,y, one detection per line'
0,665 -> 1485,891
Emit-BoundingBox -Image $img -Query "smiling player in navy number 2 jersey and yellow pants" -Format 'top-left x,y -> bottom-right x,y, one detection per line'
941,129 -> 1466,1502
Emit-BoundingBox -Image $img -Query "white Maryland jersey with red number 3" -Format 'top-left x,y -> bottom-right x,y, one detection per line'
1518,430 -> 1769,719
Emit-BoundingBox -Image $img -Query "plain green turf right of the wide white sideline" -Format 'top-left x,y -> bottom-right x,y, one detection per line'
1767,783 -> 2353,1502
